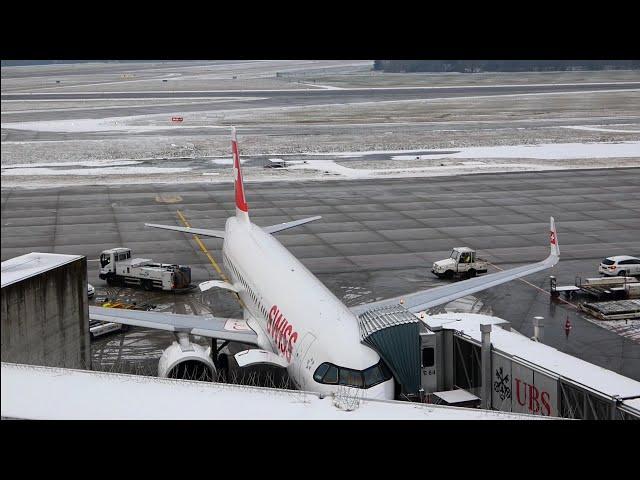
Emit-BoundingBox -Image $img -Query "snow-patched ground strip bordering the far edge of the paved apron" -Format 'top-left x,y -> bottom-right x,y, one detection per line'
2,141 -> 640,187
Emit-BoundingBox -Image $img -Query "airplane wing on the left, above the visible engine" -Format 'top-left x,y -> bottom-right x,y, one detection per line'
89,306 -> 258,345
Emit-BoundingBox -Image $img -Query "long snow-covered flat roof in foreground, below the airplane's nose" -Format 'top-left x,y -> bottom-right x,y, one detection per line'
0,362 -> 548,420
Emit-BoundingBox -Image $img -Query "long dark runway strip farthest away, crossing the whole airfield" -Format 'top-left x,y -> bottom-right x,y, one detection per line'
1,82 -> 640,122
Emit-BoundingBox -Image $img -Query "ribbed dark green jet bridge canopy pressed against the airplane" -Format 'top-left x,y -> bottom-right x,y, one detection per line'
358,305 -> 421,395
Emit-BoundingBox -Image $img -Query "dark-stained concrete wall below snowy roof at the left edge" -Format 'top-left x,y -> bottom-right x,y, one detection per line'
1,257 -> 91,368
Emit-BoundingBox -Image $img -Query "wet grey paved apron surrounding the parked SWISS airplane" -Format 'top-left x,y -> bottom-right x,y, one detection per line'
2,169 -> 640,380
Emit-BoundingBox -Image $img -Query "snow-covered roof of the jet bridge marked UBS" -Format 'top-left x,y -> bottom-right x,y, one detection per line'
423,313 -> 640,398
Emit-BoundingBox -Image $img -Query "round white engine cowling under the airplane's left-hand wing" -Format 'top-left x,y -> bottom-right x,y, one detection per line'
158,339 -> 216,382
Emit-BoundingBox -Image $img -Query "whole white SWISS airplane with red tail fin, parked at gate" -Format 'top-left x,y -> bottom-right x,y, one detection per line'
89,128 -> 560,399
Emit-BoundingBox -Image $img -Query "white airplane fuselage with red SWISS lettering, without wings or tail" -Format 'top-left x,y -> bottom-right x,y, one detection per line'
222,217 -> 394,398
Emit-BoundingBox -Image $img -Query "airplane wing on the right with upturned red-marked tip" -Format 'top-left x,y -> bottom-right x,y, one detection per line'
351,217 -> 560,315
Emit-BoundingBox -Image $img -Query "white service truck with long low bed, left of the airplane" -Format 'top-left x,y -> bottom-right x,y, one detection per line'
99,247 -> 191,290
